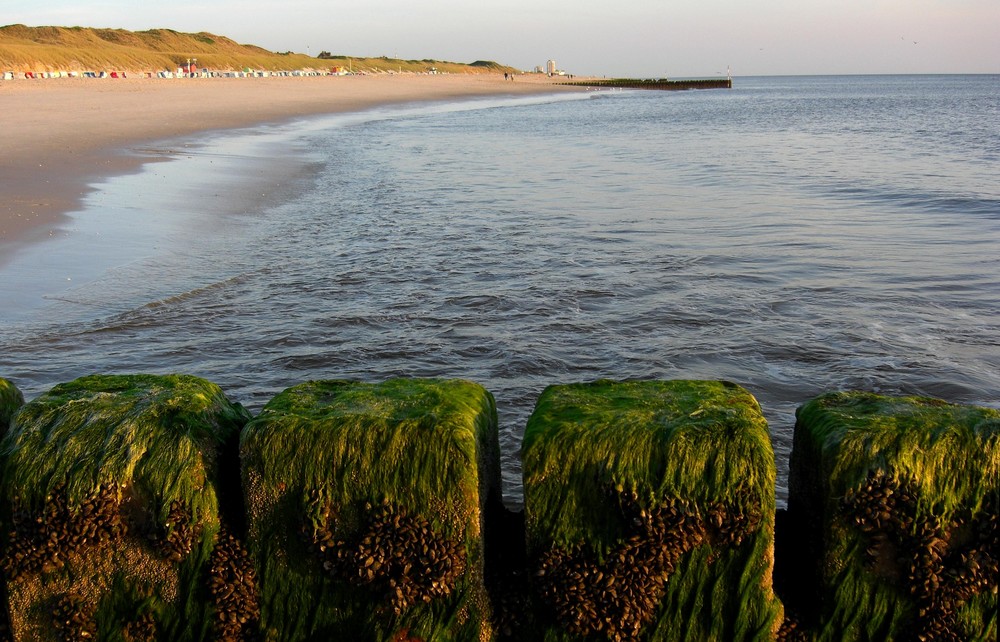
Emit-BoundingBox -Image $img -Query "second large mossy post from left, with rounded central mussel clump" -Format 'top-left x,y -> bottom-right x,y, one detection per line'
240,379 -> 500,642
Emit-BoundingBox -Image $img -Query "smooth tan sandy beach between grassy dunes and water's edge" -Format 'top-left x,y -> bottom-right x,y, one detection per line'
0,74 -> 579,244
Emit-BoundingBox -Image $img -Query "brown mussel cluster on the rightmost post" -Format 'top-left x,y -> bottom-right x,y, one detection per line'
839,470 -> 1000,642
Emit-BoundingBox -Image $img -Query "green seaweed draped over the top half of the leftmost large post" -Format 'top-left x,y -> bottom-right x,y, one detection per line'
0,375 -> 250,518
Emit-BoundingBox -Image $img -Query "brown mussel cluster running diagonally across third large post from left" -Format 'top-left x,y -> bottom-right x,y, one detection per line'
533,491 -> 761,641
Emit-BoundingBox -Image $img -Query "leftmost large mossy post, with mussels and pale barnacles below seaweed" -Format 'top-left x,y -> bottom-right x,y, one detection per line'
0,375 -> 250,642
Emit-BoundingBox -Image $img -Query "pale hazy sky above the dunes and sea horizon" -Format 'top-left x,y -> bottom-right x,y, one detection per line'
0,0 -> 1000,78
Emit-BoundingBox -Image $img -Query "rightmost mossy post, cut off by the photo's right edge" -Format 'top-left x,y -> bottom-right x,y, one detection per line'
789,392 -> 1000,642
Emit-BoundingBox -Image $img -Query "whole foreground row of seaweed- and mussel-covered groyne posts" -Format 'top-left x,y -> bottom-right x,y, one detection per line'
0,375 -> 1000,641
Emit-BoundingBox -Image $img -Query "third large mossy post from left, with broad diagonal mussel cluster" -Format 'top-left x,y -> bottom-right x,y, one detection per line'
522,381 -> 782,641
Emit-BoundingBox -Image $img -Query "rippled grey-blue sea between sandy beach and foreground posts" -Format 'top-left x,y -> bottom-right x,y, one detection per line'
0,76 -> 1000,505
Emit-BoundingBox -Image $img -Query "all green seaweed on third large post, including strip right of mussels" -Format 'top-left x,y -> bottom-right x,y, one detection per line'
522,380 -> 782,640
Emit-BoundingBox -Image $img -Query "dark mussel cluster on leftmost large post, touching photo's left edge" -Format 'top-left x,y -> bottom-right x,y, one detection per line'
0,485 -> 127,581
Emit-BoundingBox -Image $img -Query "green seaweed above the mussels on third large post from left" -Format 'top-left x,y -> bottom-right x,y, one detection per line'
522,381 -> 775,546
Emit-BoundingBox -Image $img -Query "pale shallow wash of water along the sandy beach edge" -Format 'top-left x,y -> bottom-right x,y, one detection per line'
0,93 -> 591,323
